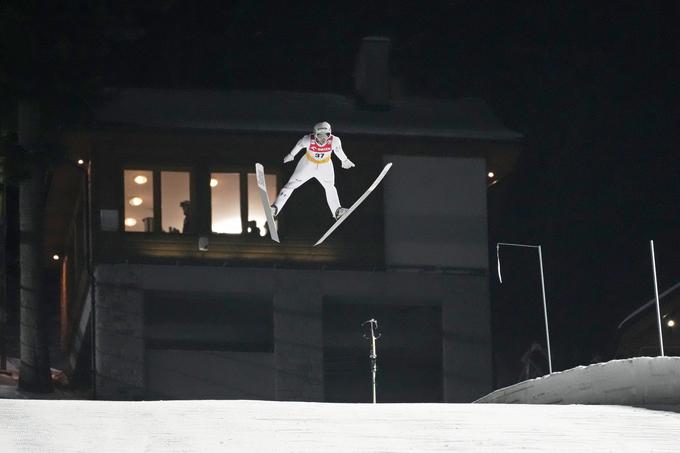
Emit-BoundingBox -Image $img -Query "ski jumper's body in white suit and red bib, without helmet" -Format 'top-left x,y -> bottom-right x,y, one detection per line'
274,134 -> 347,216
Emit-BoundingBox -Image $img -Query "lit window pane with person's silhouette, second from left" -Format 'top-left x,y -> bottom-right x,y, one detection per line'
161,171 -> 193,233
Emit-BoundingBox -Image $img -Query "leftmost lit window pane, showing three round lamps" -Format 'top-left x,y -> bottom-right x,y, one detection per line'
124,170 -> 153,231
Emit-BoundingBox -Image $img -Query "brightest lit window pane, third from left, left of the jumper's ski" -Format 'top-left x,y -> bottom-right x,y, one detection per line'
210,173 -> 243,234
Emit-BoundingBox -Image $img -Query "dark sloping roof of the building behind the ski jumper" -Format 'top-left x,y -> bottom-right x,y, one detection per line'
97,89 -> 523,141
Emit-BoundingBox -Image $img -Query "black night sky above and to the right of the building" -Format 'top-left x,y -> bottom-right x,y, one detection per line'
0,0 -> 680,382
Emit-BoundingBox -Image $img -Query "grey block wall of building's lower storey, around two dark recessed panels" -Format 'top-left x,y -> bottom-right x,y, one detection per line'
96,264 -> 492,402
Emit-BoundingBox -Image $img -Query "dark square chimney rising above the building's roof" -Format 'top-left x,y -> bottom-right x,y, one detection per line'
354,36 -> 390,109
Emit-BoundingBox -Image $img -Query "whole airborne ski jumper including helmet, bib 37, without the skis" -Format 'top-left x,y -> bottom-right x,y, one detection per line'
272,122 -> 354,220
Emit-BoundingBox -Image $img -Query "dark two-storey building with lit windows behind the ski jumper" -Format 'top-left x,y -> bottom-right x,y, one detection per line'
53,90 -> 520,402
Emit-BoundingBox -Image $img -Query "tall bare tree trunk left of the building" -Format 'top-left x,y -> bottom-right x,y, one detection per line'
19,102 -> 53,393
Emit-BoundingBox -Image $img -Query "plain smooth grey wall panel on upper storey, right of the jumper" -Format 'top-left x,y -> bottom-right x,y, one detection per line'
383,155 -> 489,269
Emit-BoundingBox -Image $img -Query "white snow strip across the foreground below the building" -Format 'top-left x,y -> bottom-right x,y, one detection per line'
0,400 -> 680,453
